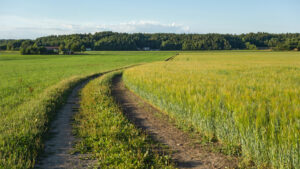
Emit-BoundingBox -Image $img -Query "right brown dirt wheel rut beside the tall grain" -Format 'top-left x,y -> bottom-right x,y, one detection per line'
112,76 -> 237,169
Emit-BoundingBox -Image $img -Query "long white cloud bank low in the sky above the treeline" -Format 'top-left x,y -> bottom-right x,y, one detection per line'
0,16 -> 190,39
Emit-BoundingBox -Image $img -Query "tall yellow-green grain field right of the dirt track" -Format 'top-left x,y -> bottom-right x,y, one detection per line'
123,51 -> 300,169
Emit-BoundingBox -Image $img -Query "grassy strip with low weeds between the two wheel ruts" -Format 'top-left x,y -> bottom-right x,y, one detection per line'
75,72 -> 173,168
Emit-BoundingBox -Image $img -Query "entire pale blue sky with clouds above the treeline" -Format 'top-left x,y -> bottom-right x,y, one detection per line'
0,0 -> 300,39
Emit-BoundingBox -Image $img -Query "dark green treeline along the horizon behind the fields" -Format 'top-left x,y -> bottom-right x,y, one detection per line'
0,32 -> 300,54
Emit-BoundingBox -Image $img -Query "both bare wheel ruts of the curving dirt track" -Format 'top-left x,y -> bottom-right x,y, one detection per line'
35,56 -> 237,169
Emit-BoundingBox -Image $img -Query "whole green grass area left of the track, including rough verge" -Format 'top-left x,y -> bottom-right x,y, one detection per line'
0,52 -> 174,168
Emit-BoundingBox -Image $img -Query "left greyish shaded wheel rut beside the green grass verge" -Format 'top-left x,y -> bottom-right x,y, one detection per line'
35,80 -> 96,169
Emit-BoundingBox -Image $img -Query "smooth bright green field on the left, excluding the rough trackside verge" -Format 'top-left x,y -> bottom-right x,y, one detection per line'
0,52 -> 172,114
